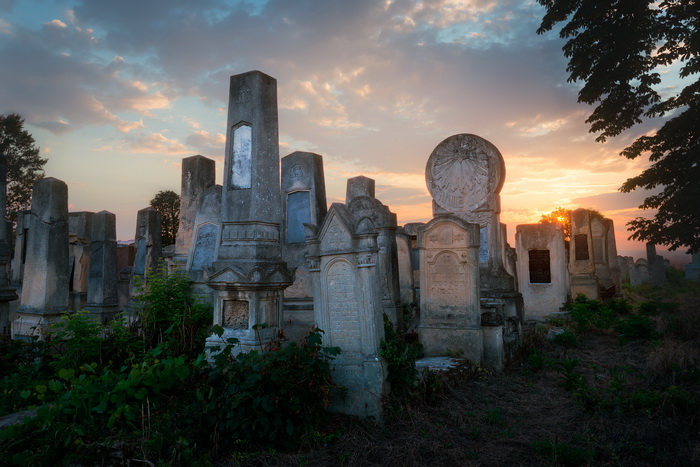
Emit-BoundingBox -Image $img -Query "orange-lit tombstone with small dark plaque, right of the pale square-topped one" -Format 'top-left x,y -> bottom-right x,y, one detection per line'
569,209 -> 600,300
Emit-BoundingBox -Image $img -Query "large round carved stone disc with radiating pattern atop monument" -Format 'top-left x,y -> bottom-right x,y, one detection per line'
425,133 -> 505,224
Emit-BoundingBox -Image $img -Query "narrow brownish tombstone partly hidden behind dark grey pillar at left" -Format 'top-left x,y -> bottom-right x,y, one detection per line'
68,212 -> 93,311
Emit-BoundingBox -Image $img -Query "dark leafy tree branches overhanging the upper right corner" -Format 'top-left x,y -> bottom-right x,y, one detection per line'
537,0 -> 700,252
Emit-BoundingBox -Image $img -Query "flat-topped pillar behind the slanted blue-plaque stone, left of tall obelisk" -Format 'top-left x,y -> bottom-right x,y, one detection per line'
173,155 -> 216,269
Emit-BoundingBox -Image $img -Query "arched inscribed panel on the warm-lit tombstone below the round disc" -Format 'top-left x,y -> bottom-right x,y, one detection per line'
429,251 -> 465,306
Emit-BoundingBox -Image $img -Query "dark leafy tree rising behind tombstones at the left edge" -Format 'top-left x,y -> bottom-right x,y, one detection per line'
0,114 -> 47,222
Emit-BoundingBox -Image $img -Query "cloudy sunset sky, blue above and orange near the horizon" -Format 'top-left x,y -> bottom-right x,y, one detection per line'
0,0 -> 688,264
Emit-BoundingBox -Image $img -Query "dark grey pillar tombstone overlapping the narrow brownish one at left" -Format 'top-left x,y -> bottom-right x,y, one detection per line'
85,211 -> 120,323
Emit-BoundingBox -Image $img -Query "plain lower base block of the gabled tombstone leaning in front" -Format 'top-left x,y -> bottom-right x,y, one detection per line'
328,353 -> 389,422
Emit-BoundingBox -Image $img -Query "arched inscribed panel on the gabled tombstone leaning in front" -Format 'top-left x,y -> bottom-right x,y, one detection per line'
326,261 -> 362,352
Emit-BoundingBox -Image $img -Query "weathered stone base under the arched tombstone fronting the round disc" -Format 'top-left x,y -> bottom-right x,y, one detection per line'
416,325 -> 484,365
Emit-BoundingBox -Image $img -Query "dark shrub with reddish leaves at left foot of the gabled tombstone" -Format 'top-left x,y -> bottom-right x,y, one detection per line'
198,329 -> 340,445
